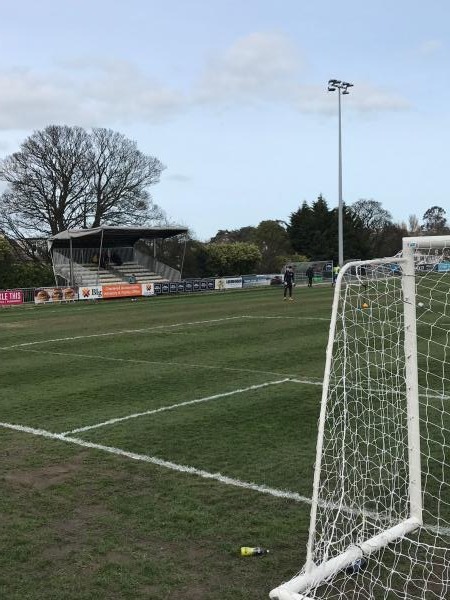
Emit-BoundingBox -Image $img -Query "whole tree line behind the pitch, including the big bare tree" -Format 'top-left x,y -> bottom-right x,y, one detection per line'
0,125 -> 450,287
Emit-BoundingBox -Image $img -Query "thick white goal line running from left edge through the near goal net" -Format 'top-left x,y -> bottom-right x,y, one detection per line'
0,422 -> 450,535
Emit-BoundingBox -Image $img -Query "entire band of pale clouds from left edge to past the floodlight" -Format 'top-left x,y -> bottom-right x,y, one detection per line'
0,32 -> 412,131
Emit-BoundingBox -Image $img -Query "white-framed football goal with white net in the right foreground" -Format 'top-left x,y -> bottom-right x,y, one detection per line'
270,236 -> 450,600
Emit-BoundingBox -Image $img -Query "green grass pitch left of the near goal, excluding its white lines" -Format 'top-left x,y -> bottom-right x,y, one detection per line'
0,286 -> 332,600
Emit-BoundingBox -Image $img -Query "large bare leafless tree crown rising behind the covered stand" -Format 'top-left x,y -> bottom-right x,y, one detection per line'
0,125 -> 164,251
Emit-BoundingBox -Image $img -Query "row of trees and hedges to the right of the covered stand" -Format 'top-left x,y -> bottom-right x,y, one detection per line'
166,195 -> 450,277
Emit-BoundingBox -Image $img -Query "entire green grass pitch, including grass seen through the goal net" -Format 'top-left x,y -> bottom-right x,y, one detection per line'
0,277 -> 450,600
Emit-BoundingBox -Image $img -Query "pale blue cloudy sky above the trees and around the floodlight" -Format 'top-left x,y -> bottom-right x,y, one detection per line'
0,0 -> 450,241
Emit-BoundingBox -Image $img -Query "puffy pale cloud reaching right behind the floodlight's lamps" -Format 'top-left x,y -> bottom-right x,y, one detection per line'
193,33 -> 410,114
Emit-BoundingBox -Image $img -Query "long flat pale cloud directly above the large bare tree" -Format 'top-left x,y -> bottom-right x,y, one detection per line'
0,61 -> 186,130
